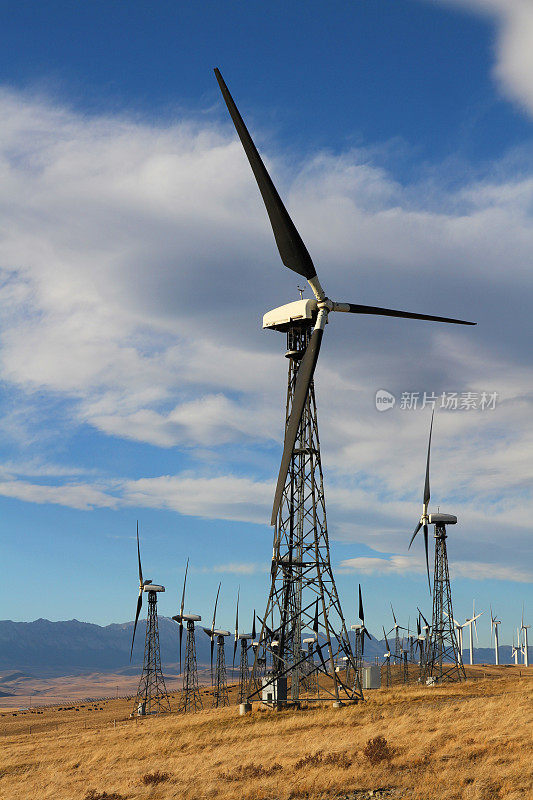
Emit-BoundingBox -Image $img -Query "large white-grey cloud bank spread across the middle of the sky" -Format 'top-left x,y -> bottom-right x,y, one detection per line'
0,92 -> 533,574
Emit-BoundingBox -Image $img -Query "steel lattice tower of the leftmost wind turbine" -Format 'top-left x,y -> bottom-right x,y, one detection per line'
133,592 -> 170,714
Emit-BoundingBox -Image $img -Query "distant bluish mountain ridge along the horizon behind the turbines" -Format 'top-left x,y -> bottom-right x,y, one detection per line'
0,617 -> 511,677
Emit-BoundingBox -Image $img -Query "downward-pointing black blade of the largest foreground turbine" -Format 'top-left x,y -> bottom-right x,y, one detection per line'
270,328 -> 323,525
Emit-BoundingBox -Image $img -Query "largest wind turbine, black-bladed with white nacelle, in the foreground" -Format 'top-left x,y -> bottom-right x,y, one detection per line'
215,69 -> 474,703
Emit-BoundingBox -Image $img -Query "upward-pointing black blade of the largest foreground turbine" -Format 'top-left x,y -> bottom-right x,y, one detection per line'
215,69 -> 316,280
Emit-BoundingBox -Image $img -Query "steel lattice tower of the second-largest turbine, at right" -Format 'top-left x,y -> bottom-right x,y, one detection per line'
424,525 -> 466,682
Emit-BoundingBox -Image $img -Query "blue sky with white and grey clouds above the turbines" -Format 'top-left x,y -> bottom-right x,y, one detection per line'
0,0 -> 533,644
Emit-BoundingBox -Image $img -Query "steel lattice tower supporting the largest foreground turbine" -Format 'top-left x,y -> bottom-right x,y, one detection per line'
248,320 -> 362,700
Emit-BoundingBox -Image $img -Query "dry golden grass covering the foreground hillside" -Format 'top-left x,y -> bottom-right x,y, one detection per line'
0,668 -> 533,800
